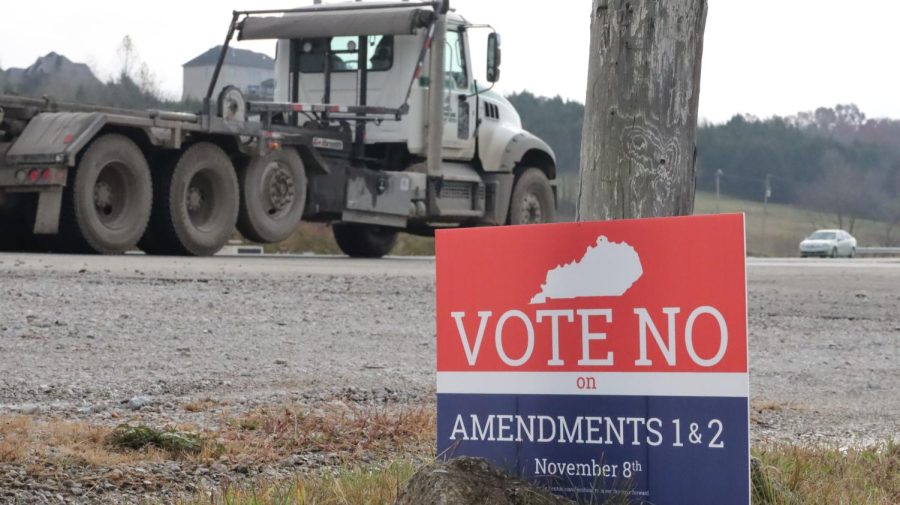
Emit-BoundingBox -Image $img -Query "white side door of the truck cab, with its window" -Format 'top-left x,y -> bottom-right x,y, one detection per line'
443,25 -> 476,160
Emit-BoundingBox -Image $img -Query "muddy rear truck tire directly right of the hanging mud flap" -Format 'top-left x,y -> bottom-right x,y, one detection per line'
57,134 -> 153,254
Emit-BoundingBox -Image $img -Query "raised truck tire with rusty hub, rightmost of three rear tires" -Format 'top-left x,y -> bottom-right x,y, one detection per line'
237,149 -> 306,243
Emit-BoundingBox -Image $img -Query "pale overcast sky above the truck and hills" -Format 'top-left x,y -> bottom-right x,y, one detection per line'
0,0 -> 900,122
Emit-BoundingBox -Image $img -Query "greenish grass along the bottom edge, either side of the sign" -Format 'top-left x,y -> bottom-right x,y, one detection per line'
181,443 -> 900,505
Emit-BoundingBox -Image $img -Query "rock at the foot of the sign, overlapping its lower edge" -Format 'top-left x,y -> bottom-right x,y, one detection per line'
395,458 -> 573,505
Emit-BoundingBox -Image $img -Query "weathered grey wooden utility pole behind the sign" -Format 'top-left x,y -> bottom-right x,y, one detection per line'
578,0 -> 707,221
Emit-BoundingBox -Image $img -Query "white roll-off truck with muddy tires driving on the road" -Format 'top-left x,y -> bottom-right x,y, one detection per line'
0,1 -> 556,257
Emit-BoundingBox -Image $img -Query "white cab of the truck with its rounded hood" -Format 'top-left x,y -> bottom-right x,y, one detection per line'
256,4 -> 556,243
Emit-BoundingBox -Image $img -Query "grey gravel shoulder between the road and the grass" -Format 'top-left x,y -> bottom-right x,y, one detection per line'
0,254 -> 900,503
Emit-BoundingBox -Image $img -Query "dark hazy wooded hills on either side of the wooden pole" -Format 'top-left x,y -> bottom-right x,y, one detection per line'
507,91 -> 900,227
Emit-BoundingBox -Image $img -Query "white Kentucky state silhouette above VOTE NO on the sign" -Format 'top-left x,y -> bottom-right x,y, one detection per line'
531,236 -> 644,305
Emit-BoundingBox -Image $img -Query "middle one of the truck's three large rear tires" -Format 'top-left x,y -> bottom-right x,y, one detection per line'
140,142 -> 239,256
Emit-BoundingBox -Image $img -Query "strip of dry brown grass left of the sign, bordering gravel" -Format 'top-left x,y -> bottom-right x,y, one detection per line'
0,402 -> 435,467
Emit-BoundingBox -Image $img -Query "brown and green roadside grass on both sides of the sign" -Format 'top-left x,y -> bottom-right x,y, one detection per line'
0,412 -> 900,505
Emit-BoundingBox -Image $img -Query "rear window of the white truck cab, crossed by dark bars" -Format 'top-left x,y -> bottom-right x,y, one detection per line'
298,35 -> 394,74
